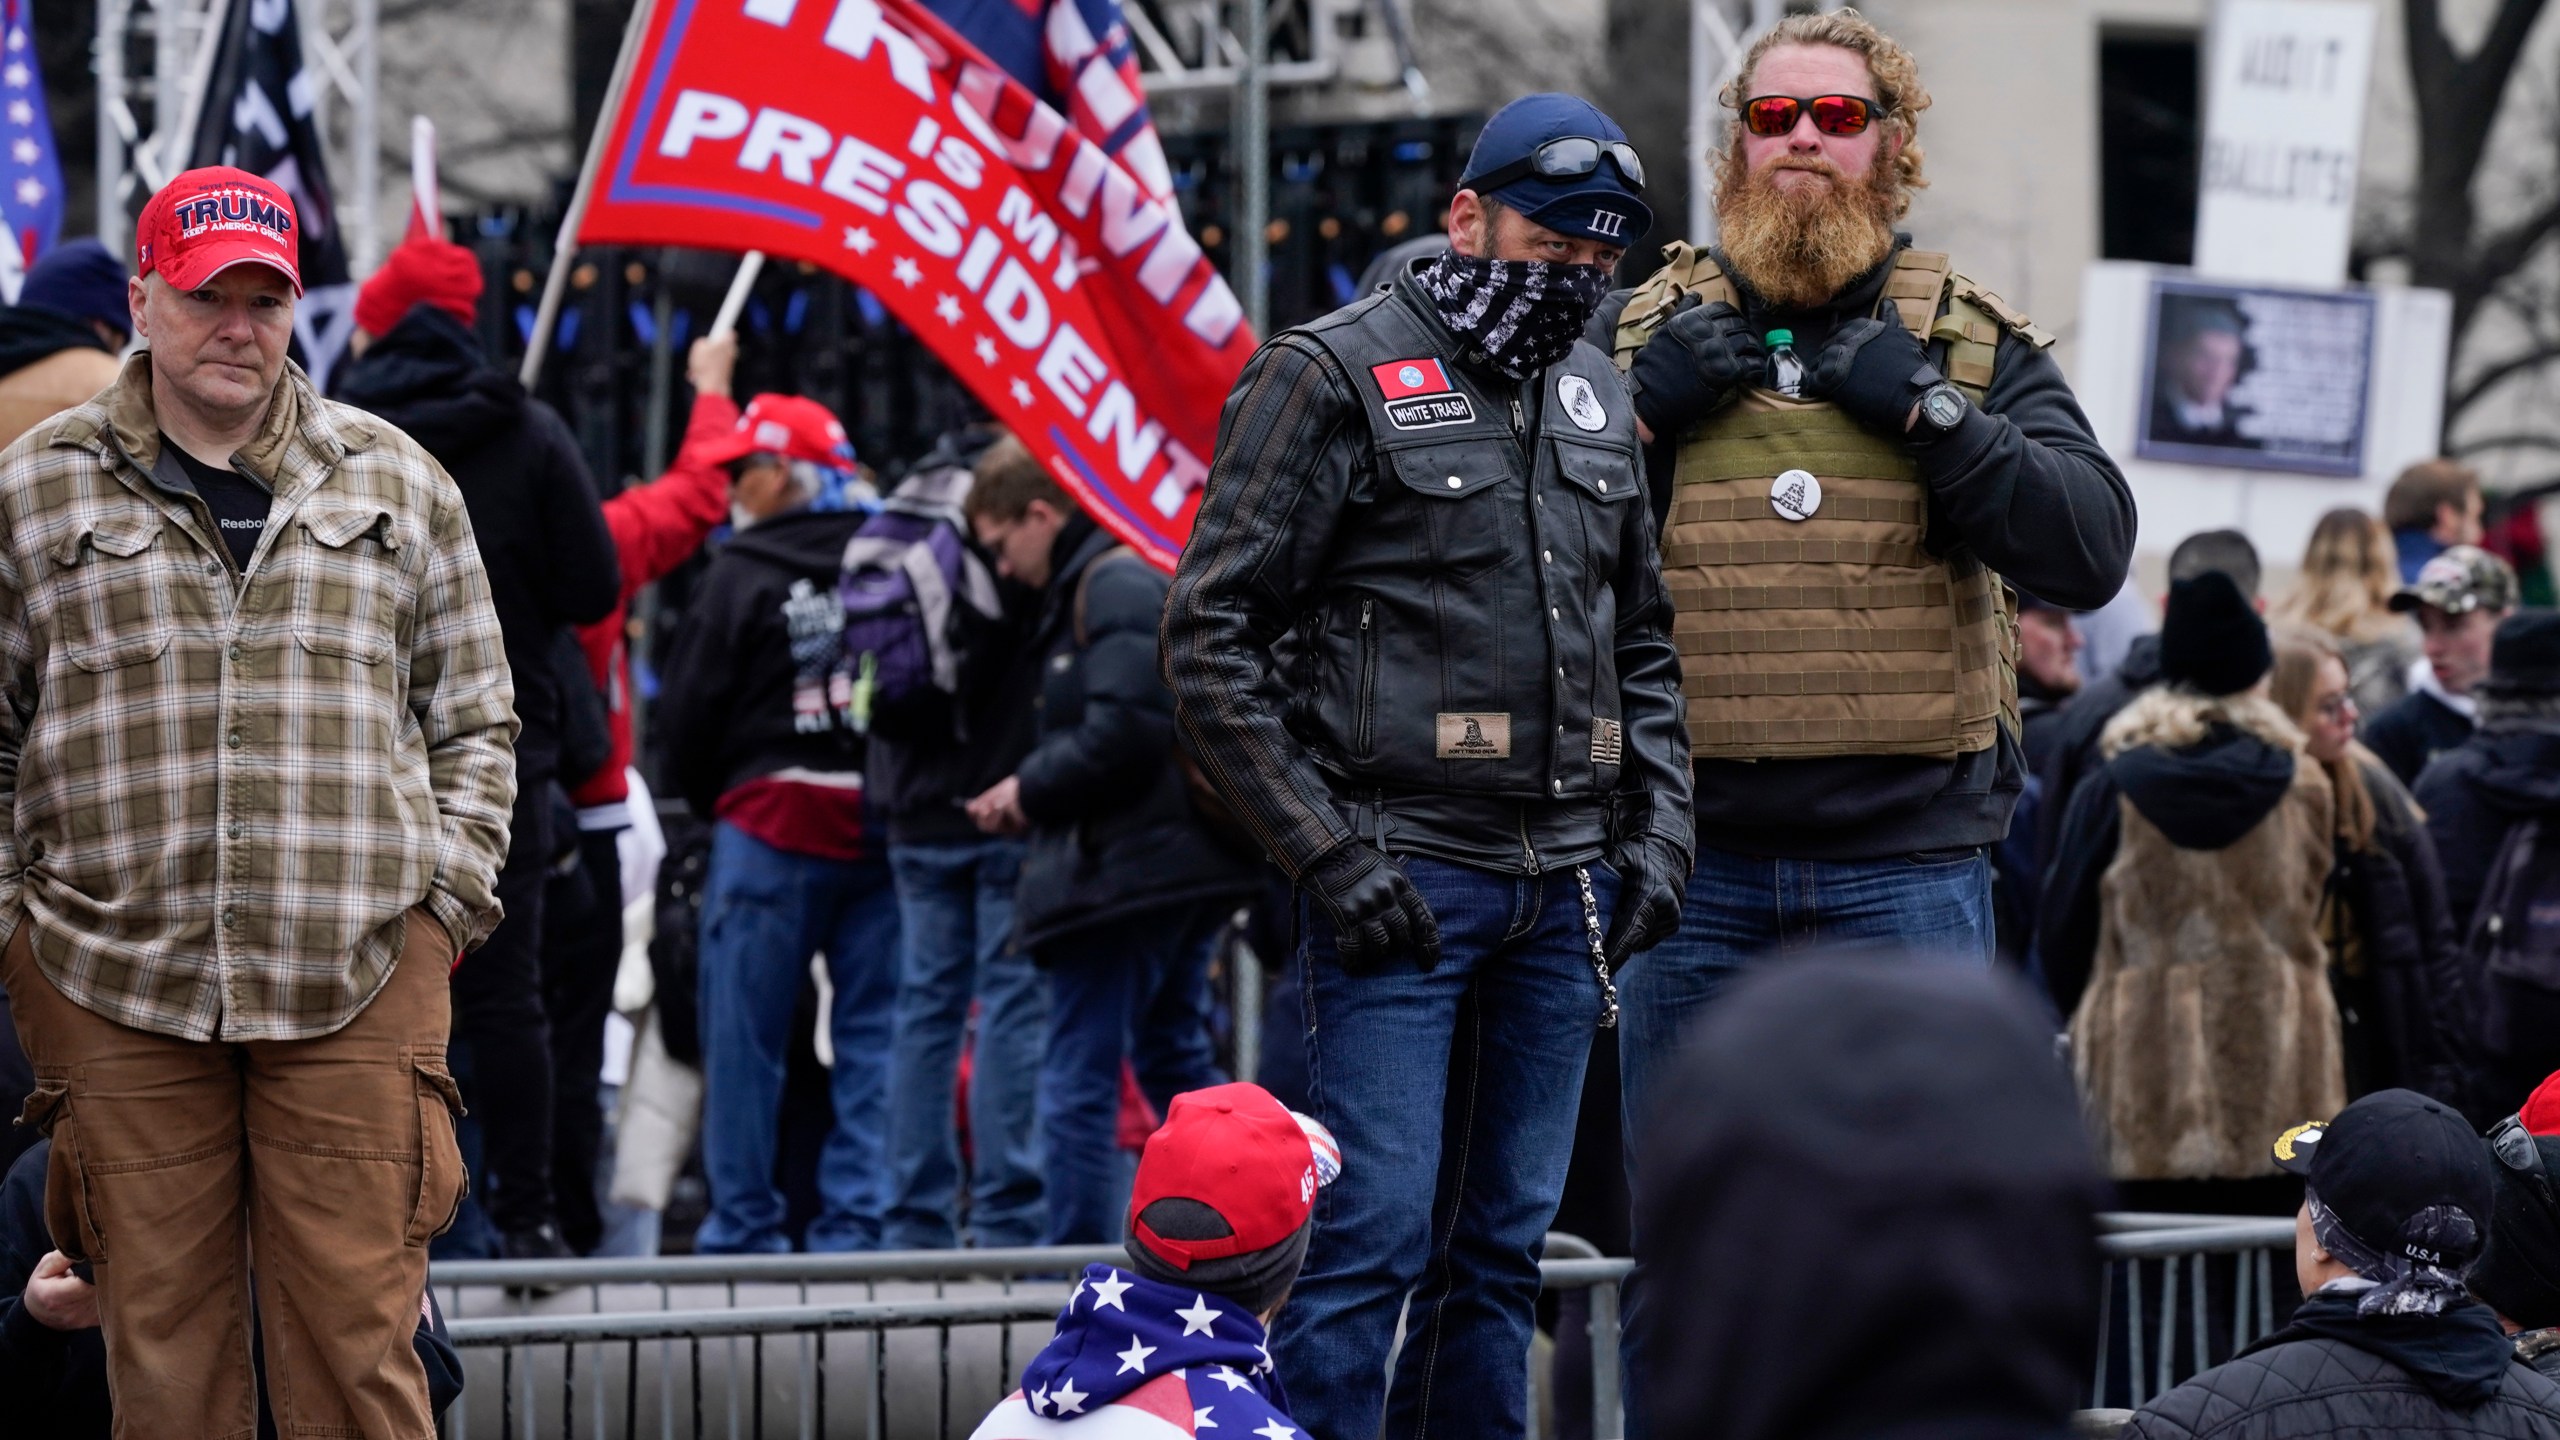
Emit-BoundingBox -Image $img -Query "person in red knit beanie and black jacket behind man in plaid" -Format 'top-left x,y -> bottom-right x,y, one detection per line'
335,238 -> 622,1258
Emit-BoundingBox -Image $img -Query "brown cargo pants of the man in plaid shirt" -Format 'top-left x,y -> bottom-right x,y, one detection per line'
0,910 -> 463,1440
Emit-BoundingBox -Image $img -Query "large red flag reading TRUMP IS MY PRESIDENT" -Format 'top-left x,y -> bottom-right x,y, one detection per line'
579,0 -> 1254,569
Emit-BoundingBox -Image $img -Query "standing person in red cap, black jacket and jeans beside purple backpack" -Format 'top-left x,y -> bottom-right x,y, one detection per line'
655,395 -> 901,1256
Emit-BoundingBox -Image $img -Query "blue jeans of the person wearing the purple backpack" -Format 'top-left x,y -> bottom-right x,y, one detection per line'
886,838 -> 1050,1250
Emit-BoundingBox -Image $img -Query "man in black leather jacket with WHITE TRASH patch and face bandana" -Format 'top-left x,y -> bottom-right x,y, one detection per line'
1162,95 -> 1690,1440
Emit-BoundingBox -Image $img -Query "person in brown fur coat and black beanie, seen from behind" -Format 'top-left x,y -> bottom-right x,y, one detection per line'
2043,566 -> 2348,1212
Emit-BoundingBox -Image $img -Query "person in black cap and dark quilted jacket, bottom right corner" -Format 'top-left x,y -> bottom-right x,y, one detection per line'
2122,1089 -> 2560,1440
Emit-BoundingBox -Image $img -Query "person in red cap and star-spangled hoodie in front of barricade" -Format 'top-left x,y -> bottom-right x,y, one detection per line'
973,1081 -> 1341,1440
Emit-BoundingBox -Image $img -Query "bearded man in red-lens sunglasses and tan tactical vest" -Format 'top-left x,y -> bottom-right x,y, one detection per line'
1590,10 -> 2135,1142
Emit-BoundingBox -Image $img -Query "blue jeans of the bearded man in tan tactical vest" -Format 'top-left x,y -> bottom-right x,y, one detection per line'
1618,848 -> 1994,1440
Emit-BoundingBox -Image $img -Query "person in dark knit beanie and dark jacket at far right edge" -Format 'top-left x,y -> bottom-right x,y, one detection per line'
2417,610 -> 2560,1094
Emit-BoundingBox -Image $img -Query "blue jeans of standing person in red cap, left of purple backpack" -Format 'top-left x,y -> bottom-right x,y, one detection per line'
694,820 -> 899,1256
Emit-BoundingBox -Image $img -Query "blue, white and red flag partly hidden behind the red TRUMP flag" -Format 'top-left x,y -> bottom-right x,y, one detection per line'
924,0 -> 1172,200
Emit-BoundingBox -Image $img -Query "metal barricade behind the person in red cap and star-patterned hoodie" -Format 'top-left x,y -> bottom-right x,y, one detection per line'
430,1235 -> 1628,1440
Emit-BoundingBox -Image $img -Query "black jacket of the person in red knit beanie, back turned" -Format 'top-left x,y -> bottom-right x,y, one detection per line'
335,305 -> 622,773
